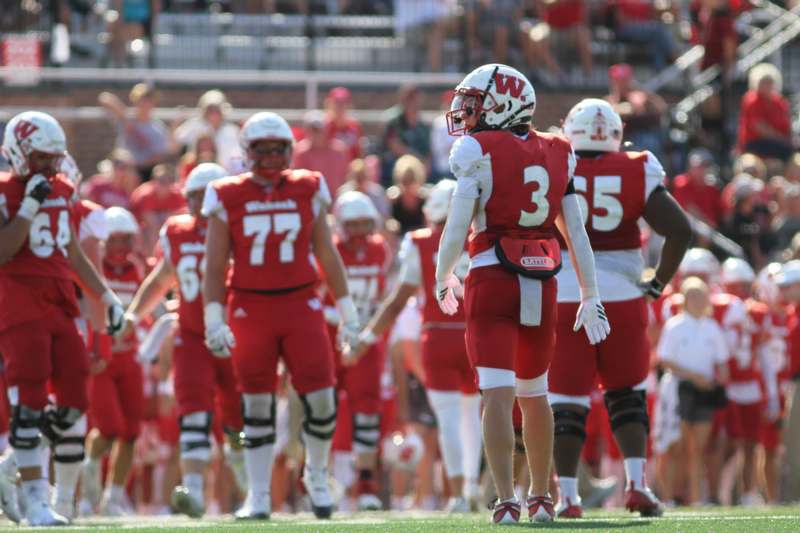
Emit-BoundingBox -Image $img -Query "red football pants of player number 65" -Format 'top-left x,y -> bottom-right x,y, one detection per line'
548,298 -> 650,396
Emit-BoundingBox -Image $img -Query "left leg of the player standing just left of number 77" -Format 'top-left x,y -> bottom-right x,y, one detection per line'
171,330 -> 214,517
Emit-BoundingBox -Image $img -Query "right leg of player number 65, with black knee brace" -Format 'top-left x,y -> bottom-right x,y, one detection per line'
597,298 -> 663,516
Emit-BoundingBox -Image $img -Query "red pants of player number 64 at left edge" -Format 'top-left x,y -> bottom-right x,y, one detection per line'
0,312 -> 89,411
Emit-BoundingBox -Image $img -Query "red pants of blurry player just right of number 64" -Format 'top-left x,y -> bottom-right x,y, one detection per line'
89,352 -> 144,441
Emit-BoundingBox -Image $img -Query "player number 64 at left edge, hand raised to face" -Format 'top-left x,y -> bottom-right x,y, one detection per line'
0,111 -> 124,526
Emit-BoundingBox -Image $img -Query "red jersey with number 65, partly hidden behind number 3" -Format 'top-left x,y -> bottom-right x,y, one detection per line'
576,152 -> 664,250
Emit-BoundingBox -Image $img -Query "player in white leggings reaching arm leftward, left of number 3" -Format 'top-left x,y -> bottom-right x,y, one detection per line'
350,179 -> 481,512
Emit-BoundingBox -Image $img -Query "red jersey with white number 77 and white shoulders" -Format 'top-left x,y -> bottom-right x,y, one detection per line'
208,170 -> 330,291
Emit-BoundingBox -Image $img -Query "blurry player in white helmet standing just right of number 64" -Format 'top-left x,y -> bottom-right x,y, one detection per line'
82,207 -> 144,516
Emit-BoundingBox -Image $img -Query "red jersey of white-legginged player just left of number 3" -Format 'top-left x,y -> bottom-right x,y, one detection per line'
411,226 -> 469,324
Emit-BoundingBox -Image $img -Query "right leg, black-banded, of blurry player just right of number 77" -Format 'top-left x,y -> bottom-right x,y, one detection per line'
344,344 -> 385,511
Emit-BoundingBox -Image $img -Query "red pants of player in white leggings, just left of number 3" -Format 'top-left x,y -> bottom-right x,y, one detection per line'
421,326 -> 478,394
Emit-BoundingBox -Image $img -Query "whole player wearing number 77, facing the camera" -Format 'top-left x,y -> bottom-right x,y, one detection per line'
202,112 -> 359,519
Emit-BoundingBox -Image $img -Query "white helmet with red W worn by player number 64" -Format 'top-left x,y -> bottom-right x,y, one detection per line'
2,111 -> 67,176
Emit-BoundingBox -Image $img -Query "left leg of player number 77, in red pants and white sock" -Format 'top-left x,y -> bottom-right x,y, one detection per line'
230,293 -> 284,520
